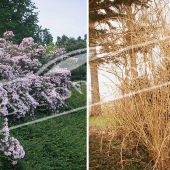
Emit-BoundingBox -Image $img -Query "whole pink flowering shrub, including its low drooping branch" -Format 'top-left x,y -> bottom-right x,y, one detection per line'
0,31 -> 74,164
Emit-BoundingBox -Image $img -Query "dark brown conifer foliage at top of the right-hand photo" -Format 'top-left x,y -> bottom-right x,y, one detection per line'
89,0 -> 150,44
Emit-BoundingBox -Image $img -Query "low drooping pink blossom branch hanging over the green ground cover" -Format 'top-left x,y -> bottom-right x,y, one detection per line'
0,118 -> 25,165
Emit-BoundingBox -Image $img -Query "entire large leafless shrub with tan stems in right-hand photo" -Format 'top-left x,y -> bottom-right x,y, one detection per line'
90,0 -> 170,170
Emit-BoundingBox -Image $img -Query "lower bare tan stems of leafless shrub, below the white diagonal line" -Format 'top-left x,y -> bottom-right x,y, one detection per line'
111,76 -> 170,170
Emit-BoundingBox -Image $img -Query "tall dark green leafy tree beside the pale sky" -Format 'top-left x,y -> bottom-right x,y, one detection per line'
0,0 -> 38,43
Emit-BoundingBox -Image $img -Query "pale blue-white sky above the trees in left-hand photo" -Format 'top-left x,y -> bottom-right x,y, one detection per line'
32,0 -> 87,42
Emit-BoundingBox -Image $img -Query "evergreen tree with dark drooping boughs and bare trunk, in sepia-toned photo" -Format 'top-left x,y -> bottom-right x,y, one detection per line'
89,0 -> 149,115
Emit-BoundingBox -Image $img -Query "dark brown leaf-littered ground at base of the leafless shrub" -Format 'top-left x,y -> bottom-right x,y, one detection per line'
89,127 -> 153,170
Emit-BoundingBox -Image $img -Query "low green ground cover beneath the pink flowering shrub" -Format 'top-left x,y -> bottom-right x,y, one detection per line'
0,85 -> 86,170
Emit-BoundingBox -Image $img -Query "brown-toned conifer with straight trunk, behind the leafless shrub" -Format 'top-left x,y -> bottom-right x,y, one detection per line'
89,0 -> 148,116
